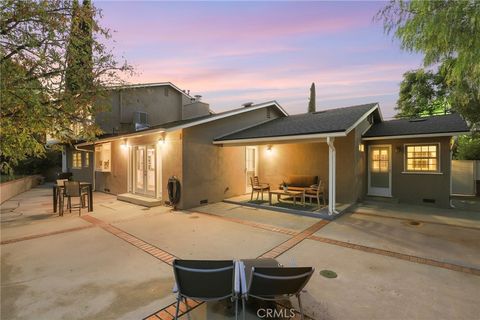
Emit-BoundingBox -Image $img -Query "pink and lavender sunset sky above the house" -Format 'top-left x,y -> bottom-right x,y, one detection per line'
94,1 -> 422,119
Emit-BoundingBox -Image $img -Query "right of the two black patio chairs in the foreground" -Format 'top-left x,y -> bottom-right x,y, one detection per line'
239,261 -> 315,320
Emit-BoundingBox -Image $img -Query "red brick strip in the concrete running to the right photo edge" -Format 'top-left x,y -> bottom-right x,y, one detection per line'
308,235 -> 480,276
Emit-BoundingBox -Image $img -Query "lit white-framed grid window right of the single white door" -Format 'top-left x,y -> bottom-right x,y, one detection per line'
405,144 -> 440,172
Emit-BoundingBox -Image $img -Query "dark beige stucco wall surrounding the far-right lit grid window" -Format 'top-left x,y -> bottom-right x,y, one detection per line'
368,137 -> 451,207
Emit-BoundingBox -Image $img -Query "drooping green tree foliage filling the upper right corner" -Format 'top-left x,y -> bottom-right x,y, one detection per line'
376,0 -> 480,124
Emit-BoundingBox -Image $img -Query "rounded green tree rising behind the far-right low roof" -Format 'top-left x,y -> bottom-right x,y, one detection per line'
395,69 -> 451,118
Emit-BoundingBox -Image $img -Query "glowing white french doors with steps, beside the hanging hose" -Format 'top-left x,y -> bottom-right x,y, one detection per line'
133,145 -> 157,197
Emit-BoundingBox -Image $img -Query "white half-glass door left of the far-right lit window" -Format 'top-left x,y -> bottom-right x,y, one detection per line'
368,145 -> 392,197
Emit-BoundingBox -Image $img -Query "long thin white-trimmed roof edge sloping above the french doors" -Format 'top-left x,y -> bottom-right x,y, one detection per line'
74,100 -> 288,146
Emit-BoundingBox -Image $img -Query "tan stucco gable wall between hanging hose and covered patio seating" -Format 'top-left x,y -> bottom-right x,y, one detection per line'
182,108 -> 279,208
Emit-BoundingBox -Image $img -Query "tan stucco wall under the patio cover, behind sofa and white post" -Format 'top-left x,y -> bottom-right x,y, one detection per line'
258,133 -> 357,203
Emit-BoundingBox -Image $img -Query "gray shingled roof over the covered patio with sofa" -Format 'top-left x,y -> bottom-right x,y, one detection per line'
215,103 -> 377,141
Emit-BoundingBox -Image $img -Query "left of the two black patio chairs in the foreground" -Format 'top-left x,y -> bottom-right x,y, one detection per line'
173,260 -> 240,319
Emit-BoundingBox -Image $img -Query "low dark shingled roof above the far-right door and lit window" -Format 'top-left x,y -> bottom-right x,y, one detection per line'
363,113 -> 469,138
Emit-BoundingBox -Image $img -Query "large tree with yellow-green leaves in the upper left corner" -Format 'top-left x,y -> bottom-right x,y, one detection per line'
0,0 -> 131,172
